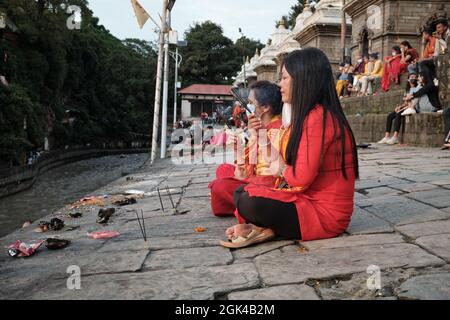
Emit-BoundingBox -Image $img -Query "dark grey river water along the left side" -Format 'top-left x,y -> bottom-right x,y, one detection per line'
0,154 -> 148,237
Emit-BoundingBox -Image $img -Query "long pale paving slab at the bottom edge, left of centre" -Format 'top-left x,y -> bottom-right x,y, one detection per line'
16,263 -> 259,300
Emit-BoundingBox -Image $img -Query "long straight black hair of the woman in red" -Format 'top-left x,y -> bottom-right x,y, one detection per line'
283,48 -> 359,178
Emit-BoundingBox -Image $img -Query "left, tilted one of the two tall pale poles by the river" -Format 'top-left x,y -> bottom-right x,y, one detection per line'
150,0 -> 168,164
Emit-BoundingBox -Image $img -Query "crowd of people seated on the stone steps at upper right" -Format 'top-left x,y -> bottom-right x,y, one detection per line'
336,20 -> 450,149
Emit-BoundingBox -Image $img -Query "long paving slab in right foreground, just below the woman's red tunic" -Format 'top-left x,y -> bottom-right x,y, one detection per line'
255,244 -> 445,285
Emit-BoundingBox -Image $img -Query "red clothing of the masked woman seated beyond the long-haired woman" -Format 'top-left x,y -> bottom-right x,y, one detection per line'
208,116 -> 281,223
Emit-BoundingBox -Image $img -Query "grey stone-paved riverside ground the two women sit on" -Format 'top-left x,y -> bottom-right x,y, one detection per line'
0,146 -> 450,300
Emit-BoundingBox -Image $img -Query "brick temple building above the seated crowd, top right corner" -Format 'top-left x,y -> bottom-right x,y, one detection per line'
344,0 -> 450,62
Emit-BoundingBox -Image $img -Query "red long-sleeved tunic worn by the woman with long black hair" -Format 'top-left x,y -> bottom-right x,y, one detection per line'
241,106 -> 355,241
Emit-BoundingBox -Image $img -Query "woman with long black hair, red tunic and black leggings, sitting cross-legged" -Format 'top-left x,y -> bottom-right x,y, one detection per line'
221,48 -> 359,248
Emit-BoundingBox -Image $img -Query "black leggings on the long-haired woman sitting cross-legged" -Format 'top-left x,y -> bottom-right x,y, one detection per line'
234,186 -> 302,240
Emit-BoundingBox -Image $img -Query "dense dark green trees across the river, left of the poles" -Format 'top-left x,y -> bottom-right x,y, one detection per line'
0,0 -> 156,168
